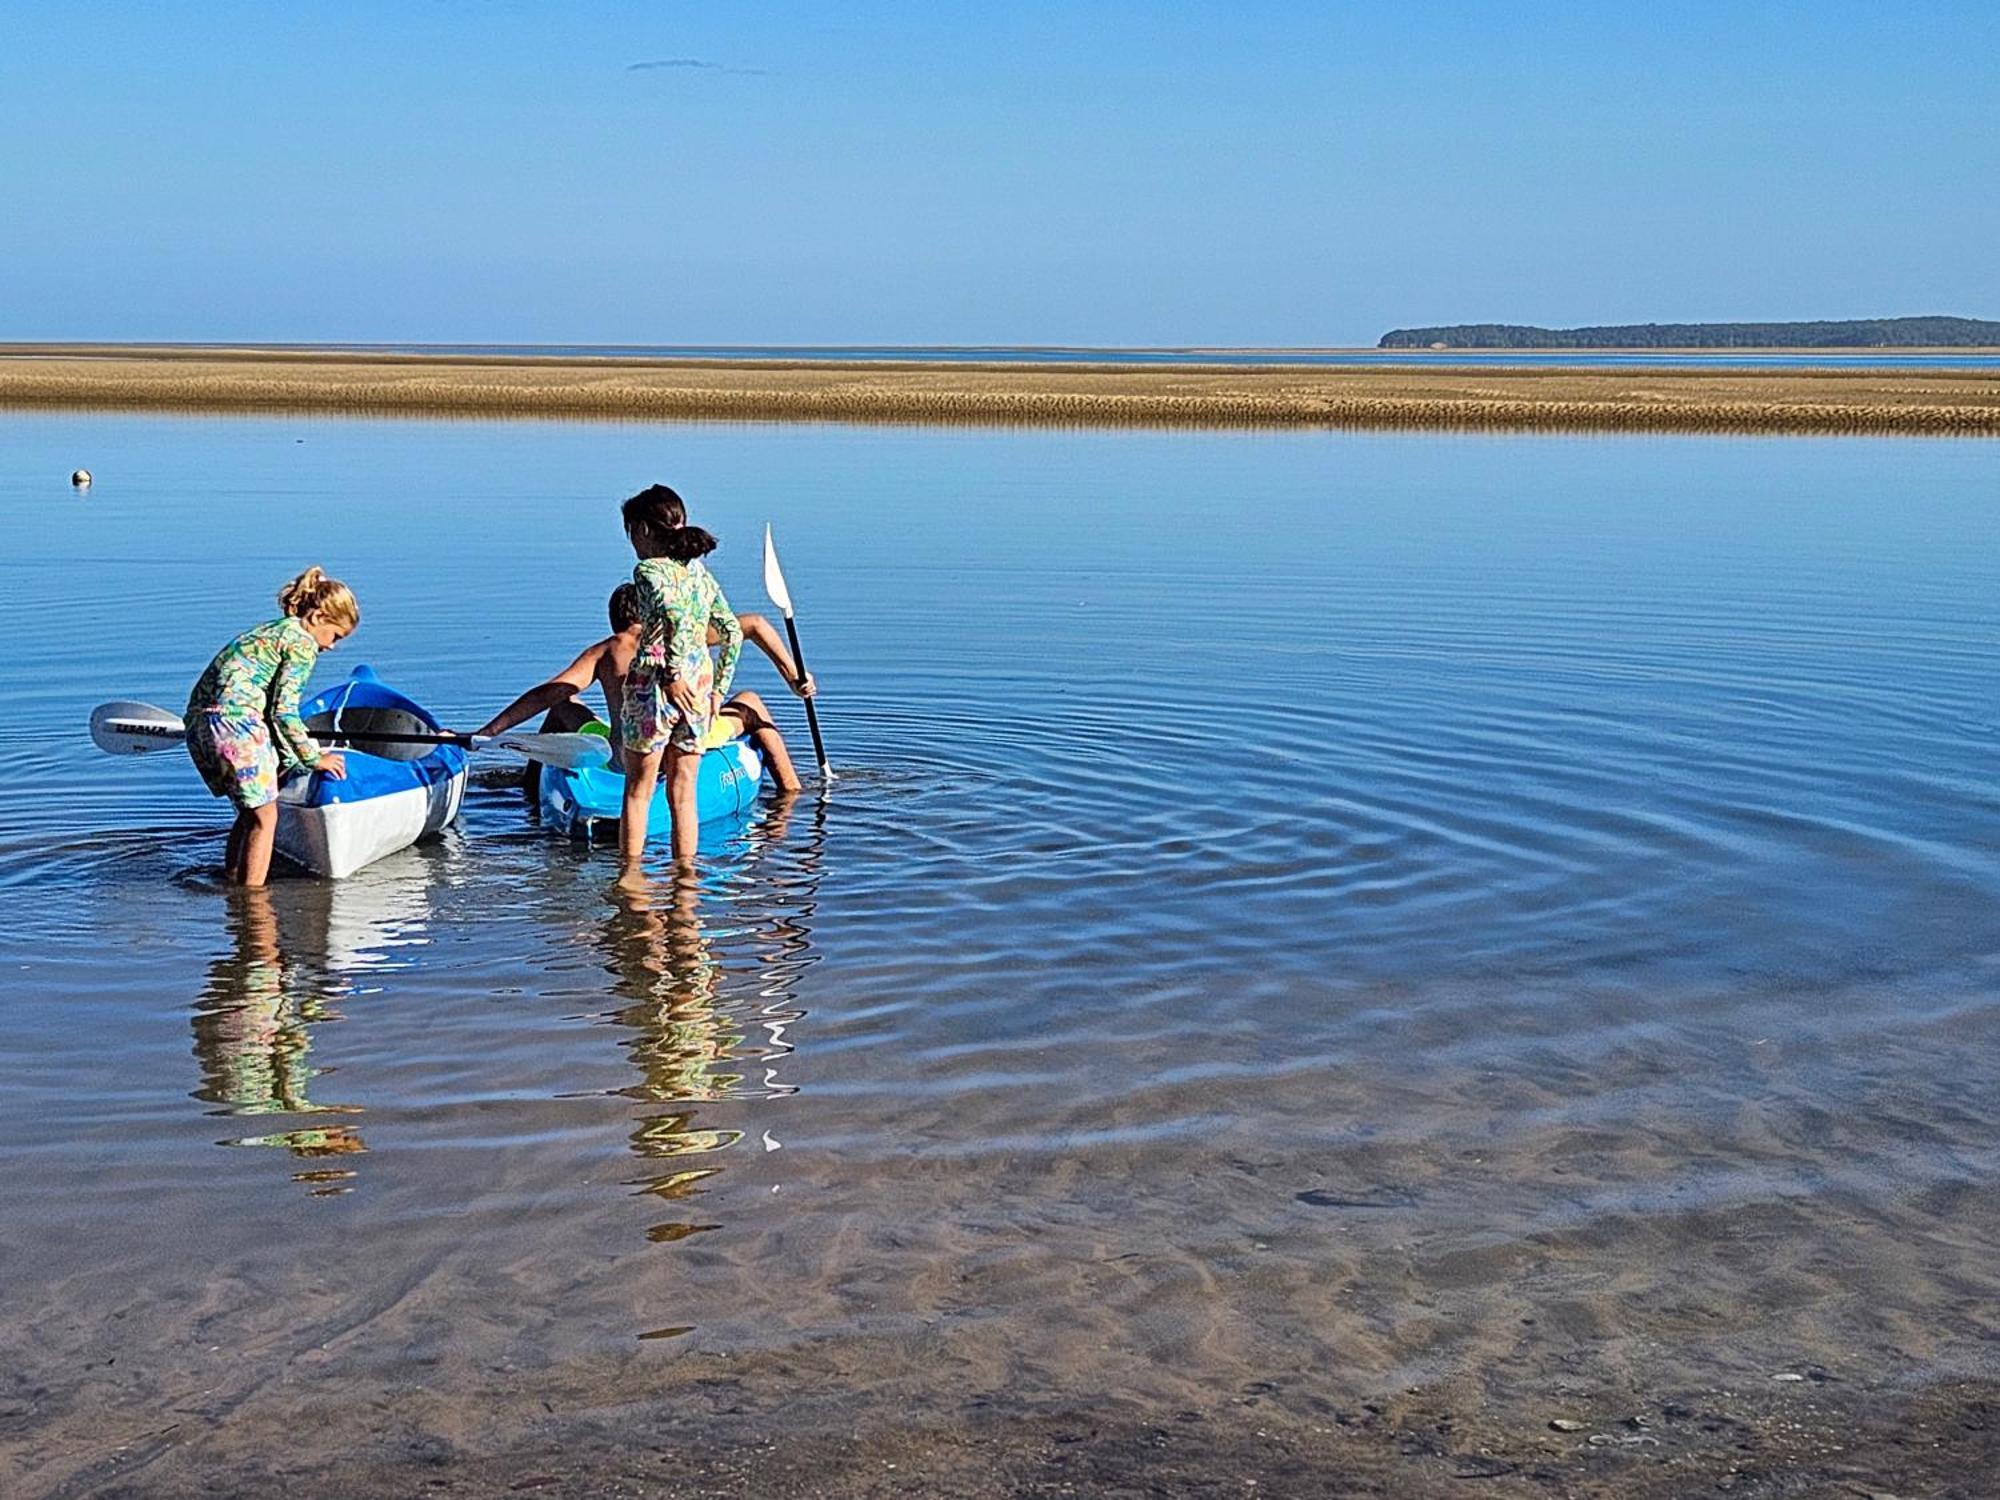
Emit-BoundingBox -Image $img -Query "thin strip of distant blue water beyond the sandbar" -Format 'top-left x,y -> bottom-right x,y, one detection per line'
15,344 -> 2000,370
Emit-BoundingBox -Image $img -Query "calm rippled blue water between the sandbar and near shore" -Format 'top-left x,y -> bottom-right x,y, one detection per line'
0,416 -> 2000,1478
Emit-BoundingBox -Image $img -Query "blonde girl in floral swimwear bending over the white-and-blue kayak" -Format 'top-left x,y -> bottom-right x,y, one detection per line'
186,568 -> 362,886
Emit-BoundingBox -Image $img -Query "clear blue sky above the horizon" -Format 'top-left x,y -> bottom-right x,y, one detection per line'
0,0 -> 2000,344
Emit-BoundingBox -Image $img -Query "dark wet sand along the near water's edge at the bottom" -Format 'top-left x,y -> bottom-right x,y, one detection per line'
39,1386 -> 2000,1500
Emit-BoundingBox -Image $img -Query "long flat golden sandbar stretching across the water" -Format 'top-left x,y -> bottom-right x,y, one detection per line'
0,344 -> 2000,436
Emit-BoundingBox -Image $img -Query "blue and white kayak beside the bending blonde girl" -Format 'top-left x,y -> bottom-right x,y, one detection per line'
278,666 -> 466,880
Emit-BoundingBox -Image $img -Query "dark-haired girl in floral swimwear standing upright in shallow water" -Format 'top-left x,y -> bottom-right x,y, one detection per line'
618,484 -> 744,876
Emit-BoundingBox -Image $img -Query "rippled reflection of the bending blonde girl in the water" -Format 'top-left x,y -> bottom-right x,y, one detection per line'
194,886 -> 366,1158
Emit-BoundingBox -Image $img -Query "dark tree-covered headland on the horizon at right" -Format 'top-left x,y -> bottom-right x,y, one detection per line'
1378,318 -> 2000,348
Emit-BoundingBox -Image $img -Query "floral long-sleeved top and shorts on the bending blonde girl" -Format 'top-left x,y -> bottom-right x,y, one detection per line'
186,616 -> 320,808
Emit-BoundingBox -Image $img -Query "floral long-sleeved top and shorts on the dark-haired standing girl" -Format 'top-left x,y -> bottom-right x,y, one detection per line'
618,558 -> 744,752
